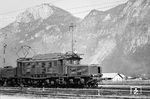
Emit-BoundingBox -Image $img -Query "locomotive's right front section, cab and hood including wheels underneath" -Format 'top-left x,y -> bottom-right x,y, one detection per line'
64,53 -> 101,87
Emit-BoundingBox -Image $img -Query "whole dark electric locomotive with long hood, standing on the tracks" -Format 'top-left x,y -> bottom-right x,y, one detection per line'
0,52 -> 101,88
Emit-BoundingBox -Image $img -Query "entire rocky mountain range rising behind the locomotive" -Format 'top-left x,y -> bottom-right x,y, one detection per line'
0,0 -> 150,75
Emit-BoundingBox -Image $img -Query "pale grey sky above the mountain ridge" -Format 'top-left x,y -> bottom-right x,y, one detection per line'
0,0 -> 127,27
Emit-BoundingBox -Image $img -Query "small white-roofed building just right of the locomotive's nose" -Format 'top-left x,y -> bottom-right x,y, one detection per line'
102,73 -> 126,81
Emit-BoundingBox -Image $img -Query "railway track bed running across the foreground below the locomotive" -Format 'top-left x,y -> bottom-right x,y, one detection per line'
0,85 -> 150,99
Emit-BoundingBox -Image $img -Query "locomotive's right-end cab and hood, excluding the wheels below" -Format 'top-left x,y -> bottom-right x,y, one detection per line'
65,53 -> 101,77
